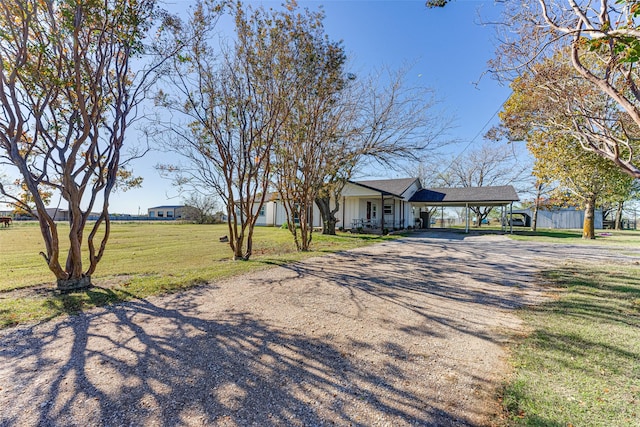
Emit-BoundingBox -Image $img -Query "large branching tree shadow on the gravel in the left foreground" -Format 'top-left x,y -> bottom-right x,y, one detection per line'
0,291 -> 471,426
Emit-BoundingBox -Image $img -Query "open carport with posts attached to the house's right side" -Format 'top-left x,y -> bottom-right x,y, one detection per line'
409,185 -> 520,233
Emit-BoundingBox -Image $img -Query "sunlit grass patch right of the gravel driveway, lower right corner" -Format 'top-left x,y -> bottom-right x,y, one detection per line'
503,264 -> 640,426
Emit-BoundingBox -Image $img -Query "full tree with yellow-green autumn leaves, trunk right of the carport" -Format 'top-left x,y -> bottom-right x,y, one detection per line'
500,51 -> 639,239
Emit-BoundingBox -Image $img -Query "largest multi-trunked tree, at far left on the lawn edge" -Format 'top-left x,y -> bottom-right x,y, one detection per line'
0,0 -> 175,290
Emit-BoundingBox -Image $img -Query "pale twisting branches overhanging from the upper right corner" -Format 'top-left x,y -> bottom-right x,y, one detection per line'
526,0 -> 640,178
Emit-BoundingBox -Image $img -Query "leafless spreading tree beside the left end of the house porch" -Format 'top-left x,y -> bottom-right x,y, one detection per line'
316,69 -> 451,234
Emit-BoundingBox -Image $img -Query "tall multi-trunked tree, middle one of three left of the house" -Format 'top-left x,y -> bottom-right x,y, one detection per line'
157,3 -> 295,260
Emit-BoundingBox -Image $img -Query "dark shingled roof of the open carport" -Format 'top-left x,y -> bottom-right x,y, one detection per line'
409,185 -> 520,206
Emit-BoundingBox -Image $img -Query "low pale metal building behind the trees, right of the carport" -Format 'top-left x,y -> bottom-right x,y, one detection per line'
513,208 -> 603,229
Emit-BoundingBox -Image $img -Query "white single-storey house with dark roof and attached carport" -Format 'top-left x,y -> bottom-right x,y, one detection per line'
256,178 -> 519,231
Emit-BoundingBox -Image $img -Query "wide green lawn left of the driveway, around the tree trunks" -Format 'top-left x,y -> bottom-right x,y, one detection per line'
0,222 -> 393,327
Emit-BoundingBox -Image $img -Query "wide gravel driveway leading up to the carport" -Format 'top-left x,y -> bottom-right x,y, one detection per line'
0,233 -> 636,426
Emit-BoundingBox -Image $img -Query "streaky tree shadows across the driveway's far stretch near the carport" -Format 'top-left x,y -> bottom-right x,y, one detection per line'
270,240 -> 538,342
